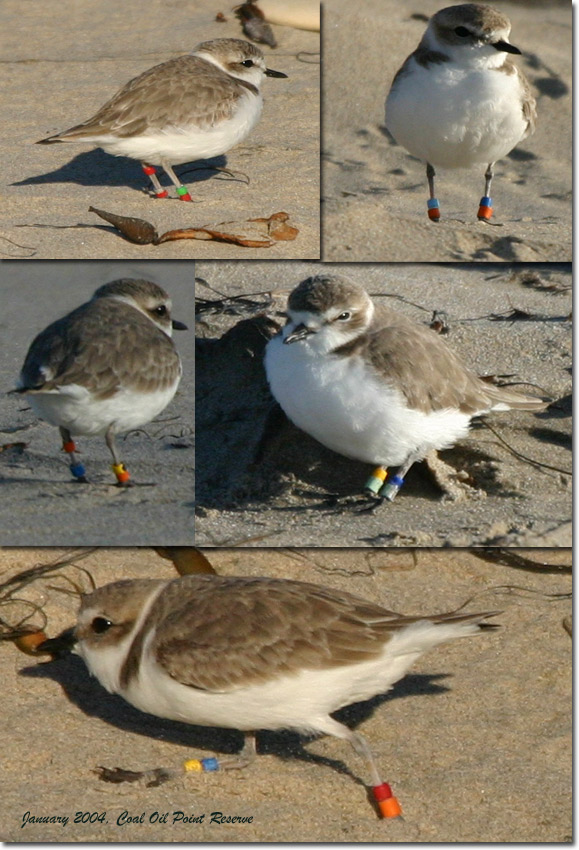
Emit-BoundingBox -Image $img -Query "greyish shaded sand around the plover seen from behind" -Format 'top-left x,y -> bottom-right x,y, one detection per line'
0,262 -> 194,546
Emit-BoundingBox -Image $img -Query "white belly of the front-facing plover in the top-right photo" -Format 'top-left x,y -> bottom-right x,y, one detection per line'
386,60 -> 527,168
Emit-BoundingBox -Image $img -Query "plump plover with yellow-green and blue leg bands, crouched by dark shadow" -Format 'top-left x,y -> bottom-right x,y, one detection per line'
265,275 -> 546,500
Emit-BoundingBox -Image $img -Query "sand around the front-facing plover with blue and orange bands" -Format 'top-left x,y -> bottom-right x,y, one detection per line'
323,0 -> 572,262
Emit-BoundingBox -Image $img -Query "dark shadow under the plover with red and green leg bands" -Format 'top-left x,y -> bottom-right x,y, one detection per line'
11,153 -> 227,191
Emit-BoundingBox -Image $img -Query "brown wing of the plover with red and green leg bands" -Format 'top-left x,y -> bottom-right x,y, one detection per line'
61,56 -> 247,138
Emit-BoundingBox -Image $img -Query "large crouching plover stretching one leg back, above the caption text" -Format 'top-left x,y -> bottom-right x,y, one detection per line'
39,576 -> 497,817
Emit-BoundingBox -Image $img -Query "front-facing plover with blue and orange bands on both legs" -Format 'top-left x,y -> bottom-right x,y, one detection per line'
386,3 -> 536,221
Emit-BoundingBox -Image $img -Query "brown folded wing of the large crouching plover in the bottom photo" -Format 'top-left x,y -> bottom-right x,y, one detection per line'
154,576 -> 412,691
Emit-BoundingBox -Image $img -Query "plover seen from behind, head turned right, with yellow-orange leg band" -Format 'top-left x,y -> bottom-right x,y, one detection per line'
13,279 -> 186,486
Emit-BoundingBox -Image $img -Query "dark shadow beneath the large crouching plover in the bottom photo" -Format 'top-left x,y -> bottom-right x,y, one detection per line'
20,655 -> 450,785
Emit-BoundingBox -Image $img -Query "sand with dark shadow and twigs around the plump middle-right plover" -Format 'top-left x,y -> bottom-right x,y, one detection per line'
195,263 -> 571,547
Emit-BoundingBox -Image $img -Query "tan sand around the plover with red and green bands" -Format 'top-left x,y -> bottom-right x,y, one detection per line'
0,0 -> 320,260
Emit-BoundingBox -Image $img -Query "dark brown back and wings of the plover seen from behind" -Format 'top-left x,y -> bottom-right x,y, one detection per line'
21,299 -> 180,399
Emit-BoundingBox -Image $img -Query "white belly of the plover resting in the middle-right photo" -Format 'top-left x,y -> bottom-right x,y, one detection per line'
265,336 -> 470,466
